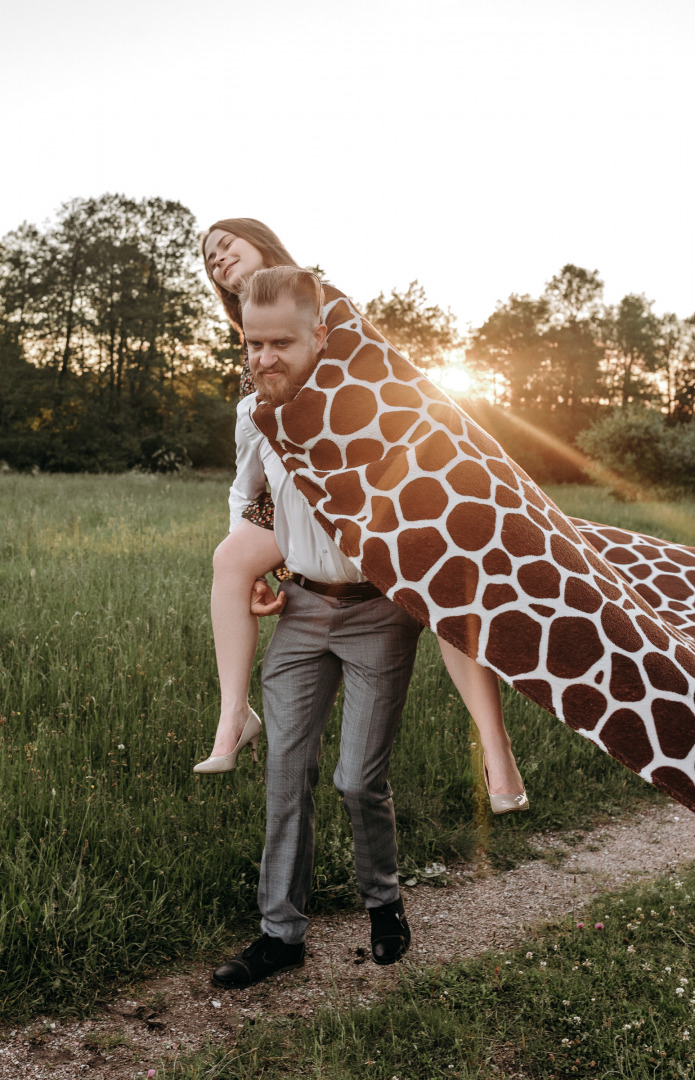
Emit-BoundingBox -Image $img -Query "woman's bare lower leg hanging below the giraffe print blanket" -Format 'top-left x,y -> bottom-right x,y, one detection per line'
437,637 -> 523,795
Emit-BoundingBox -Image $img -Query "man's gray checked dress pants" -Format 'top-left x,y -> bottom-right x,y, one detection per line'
258,582 -> 422,944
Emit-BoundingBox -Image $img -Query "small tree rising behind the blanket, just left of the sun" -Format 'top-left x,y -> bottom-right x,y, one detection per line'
364,281 -> 463,368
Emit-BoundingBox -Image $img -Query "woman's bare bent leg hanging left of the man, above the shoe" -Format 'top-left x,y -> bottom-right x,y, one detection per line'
210,521 -> 283,757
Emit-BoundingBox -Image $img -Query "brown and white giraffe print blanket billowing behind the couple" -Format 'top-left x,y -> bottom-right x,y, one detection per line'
254,286 -> 695,810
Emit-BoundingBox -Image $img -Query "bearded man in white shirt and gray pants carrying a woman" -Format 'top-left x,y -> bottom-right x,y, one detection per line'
213,267 -> 421,987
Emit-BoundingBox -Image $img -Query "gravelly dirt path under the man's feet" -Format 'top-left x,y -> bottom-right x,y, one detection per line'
0,805 -> 695,1080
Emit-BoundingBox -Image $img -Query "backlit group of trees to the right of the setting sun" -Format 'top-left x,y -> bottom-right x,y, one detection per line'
467,264 -> 695,420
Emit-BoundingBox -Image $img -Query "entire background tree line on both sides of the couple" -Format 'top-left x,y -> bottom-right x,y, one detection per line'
0,194 -> 695,481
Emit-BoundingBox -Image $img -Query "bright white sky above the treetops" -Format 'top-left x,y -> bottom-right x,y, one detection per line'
0,0 -> 695,328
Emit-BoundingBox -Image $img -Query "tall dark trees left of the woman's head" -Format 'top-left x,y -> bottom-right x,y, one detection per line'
0,194 -> 241,471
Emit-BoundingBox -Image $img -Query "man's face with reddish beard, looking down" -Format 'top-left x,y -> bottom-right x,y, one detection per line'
243,296 -> 326,406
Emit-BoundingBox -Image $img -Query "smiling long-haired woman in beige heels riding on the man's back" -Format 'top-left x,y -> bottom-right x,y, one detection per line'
195,218 -> 529,813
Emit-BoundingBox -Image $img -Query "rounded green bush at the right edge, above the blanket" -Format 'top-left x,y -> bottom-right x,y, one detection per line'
577,407 -> 695,491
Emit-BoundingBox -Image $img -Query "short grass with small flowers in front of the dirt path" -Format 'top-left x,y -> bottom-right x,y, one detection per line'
155,870 -> 695,1080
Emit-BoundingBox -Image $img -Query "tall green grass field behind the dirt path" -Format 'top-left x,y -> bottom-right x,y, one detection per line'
0,475 -> 695,1016
